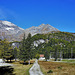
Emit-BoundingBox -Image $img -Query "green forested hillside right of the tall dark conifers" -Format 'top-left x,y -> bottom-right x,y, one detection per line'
32,32 -> 75,60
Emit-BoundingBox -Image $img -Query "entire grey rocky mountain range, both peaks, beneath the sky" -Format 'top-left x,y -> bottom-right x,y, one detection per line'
0,21 -> 59,41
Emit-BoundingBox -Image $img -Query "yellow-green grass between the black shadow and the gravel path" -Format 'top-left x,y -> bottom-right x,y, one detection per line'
10,61 -> 34,75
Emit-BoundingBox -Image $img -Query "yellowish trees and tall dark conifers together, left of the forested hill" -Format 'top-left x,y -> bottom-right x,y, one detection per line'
0,33 -> 34,62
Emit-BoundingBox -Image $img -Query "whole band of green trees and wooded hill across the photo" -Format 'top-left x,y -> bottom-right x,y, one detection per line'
0,32 -> 75,62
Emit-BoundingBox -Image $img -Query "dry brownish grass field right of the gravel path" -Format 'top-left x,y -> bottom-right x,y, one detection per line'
39,61 -> 75,75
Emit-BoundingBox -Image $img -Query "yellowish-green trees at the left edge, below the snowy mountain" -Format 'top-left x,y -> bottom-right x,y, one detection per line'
0,39 -> 18,62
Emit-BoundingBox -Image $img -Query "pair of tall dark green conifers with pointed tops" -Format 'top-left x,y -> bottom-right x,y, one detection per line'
19,33 -> 33,62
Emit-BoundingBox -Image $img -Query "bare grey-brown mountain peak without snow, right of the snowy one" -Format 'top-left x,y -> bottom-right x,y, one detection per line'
25,24 -> 59,36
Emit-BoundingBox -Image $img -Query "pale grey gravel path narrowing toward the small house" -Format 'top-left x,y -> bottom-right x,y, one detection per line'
29,60 -> 44,75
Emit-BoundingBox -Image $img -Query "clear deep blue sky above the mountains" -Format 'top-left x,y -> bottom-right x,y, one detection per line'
0,0 -> 75,32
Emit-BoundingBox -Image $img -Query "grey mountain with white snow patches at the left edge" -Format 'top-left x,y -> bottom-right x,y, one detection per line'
0,21 -> 24,41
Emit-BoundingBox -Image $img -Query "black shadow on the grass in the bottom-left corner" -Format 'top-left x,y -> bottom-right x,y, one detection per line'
0,66 -> 15,75
